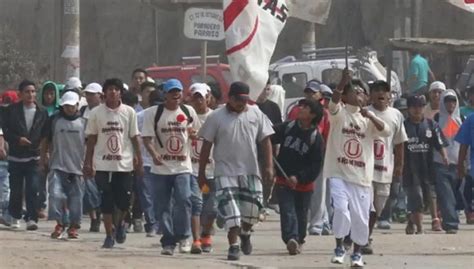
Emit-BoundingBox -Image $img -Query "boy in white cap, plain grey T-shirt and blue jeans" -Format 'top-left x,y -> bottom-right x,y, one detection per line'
41,91 -> 86,239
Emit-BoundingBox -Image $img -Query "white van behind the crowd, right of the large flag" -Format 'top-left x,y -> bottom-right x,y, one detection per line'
269,48 -> 402,115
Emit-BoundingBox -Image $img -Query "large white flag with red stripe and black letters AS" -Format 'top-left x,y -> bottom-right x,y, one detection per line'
224,0 -> 289,100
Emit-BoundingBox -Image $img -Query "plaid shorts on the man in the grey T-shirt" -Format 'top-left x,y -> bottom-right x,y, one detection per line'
215,175 -> 263,231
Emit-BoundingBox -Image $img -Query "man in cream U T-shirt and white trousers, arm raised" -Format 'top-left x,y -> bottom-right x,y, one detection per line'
323,69 -> 389,267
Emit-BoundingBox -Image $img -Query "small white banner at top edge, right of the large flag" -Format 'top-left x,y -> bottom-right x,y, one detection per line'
286,0 -> 332,24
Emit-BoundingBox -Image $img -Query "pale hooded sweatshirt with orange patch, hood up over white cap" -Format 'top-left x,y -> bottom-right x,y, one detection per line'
434,90 -> 462,164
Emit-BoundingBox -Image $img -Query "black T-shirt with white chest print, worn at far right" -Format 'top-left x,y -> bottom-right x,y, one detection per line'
403,119 -> 447,186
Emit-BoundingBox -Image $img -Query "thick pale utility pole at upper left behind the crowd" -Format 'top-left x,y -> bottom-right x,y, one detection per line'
59,0 -> 81,81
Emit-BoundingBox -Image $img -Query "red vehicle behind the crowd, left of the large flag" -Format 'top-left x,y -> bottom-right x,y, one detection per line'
146,55 -> 232,102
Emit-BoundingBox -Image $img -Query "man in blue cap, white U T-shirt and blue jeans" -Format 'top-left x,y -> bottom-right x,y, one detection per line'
143,79 -> 201,255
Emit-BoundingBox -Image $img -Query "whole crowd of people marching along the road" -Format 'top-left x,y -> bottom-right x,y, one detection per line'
0,65 -> 474,267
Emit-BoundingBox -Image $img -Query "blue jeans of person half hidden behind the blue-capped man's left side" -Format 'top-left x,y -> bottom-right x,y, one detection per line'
138,166 -> 164,232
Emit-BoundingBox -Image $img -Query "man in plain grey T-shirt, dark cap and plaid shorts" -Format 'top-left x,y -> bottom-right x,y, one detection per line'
198,82 -> 274,260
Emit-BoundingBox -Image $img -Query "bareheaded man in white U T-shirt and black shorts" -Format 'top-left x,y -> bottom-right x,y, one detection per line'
84,79 -> 143,248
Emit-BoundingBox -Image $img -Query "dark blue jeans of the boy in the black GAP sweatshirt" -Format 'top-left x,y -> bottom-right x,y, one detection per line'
275,185 -> 313,244
